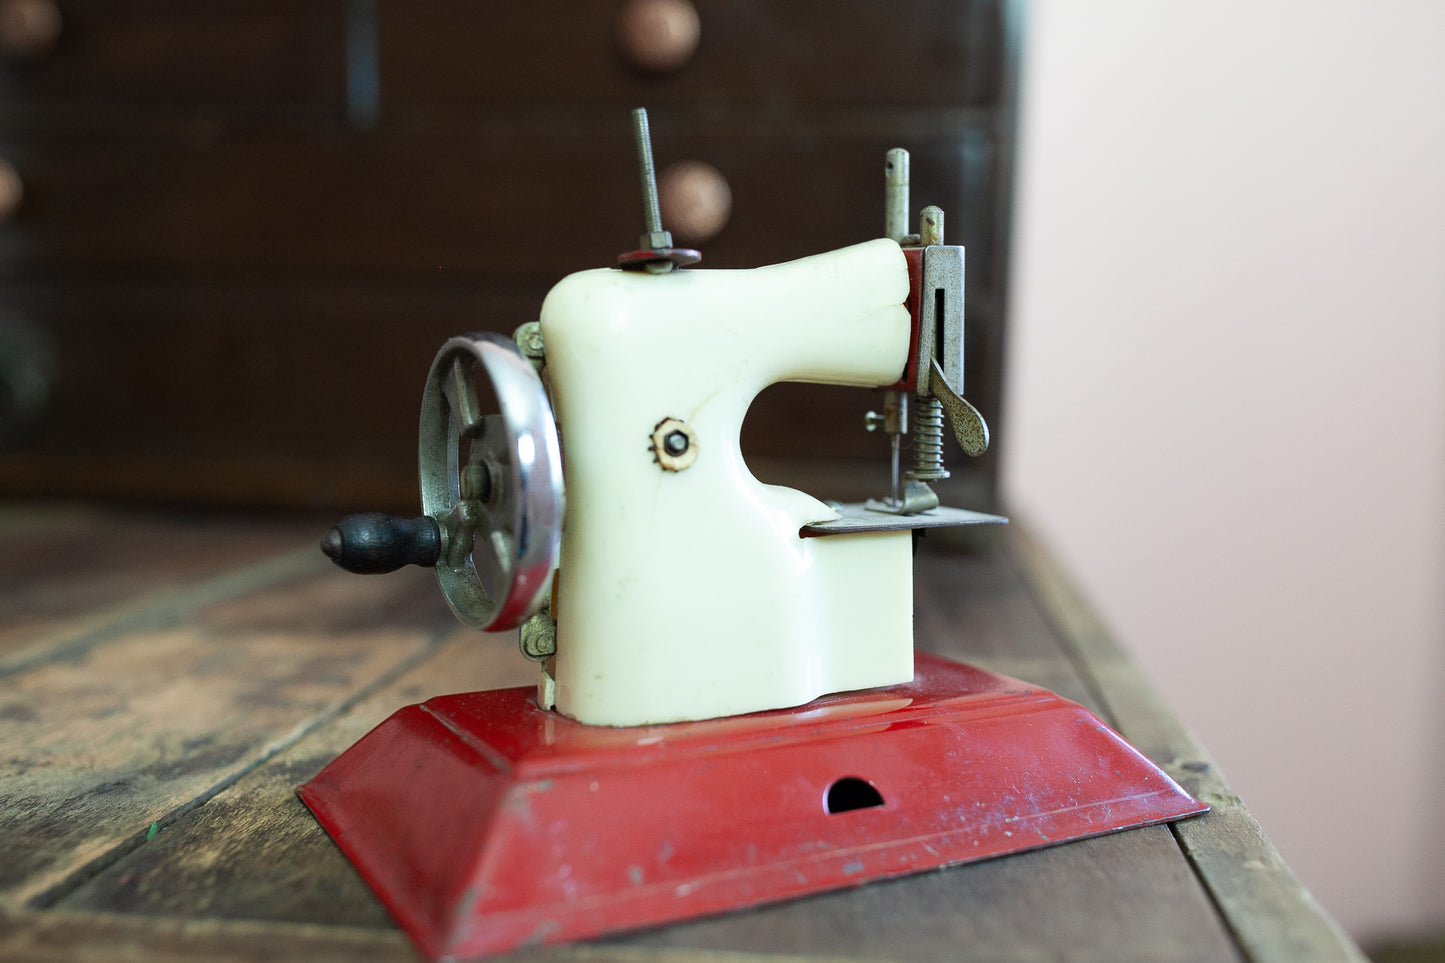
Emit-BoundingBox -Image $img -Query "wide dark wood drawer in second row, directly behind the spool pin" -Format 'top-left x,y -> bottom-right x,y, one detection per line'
0,122 -> 996,283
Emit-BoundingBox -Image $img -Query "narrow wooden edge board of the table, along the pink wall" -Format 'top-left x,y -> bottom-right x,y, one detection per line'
1006,526 -> 1366,963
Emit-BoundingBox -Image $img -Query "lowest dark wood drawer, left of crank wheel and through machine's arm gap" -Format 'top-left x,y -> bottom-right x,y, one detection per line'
0,267 -> 997,510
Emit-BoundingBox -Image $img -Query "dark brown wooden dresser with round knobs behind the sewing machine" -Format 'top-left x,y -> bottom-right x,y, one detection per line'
0,0 -> 1012,510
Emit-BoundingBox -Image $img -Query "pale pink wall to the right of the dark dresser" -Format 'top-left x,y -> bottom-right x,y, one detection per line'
1000,0 -> 1445,938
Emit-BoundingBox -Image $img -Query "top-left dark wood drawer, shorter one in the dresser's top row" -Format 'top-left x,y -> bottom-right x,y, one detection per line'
0,0 -> 345,113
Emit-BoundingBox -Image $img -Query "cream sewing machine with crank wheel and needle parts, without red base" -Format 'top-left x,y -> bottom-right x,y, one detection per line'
327,112 -> 1003,726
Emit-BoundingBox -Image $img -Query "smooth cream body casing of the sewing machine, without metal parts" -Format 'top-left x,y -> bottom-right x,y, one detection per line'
542,240 -> 913,726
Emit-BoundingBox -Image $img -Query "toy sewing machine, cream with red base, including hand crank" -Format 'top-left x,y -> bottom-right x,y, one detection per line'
301,111 -> 1207,957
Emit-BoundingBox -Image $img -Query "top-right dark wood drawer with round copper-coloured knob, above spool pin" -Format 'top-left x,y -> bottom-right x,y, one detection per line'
380,0 -> 1000,116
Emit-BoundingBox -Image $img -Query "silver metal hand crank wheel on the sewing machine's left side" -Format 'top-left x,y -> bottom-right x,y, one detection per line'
419,331 -> 562,630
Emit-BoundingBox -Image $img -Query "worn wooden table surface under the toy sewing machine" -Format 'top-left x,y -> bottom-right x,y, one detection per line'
0,503 -> 1363,963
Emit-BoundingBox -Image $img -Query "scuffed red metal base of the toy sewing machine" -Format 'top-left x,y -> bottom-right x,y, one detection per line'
299,654 -> 1208,957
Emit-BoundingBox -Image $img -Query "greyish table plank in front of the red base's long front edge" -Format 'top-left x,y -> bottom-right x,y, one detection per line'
609,827 -> 1240,963
